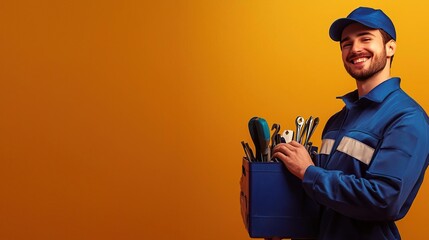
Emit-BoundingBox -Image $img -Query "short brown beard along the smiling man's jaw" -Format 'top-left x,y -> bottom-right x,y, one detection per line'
344,49 -> 387,81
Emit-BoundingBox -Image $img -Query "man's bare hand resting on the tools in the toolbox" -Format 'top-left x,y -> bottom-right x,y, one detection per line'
272,141 -> 314,179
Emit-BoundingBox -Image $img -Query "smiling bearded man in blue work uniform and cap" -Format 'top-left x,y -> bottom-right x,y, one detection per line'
273,7 -> 429,240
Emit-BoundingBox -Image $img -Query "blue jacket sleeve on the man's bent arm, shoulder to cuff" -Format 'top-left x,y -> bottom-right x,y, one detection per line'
303,112 -> 429,221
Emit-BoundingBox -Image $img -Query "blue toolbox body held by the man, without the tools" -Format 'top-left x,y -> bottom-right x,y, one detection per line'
240,157 -> 319,239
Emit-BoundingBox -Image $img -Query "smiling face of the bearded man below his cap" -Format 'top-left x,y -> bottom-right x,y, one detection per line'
340,23 -> 387,81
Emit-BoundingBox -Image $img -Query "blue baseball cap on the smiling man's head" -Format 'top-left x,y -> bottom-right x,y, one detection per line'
329,7 -> 396,42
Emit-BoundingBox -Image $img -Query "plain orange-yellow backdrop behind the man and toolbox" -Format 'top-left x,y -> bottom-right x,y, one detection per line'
0,0 -> 429,240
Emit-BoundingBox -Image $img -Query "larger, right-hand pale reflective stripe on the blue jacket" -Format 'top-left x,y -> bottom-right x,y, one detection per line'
337,137 -> 374,165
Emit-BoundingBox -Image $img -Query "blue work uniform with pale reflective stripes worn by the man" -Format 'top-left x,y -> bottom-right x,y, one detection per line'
303,78 -> 429,240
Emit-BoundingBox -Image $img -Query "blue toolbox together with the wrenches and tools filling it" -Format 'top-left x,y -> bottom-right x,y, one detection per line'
240,116 -> 319,238
